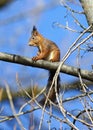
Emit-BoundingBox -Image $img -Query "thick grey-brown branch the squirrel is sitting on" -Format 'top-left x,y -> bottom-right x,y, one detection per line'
0,52 -> 93,81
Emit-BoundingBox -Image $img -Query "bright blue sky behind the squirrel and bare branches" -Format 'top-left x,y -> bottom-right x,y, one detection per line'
0,0 -> 93,128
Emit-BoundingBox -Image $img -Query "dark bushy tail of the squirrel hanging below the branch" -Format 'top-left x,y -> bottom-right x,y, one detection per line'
39,70 -> 60,105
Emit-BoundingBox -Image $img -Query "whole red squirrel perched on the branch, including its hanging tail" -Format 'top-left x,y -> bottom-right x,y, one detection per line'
29,26 -> 60,105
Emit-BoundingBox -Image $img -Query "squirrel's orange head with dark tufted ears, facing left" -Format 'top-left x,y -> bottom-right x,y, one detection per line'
29,26 -> 43,47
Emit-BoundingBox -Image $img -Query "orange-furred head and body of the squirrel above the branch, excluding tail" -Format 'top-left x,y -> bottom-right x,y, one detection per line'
29,25 -> 60,62
